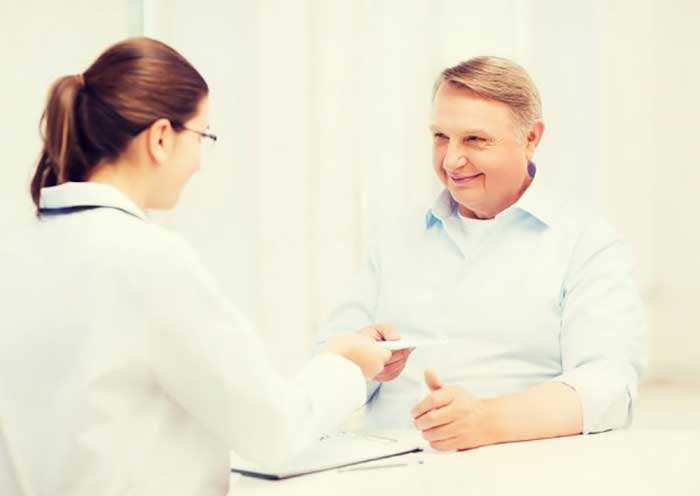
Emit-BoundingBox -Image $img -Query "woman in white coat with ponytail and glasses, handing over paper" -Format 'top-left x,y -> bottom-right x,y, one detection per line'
0,38 -> 390,495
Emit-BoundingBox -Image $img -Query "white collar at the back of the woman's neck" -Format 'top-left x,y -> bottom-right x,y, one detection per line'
39,182 -> 146,220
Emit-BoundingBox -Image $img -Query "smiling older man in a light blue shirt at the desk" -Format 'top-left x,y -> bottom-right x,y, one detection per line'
321,57 -> 647,450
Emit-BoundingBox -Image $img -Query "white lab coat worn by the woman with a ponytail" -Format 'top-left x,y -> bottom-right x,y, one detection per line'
0,183 -> 365,496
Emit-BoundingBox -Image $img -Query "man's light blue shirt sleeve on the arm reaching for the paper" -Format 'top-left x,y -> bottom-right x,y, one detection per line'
315,245 -> 381,399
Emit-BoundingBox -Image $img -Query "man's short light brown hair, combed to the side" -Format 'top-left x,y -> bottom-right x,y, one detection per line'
433,57 -> 542,137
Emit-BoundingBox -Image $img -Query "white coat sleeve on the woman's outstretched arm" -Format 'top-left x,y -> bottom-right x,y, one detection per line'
136,235 -> 365,467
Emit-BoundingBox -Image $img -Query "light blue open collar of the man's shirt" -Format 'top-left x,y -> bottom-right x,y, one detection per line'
425,170 -> 558,229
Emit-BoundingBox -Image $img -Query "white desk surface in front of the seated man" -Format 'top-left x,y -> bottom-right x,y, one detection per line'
229,430 -> 700,496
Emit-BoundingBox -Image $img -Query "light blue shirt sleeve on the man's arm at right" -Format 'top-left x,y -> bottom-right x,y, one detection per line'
554,224 -> 647,434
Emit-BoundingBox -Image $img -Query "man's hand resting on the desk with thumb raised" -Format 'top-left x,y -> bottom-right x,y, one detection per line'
411,369 -> 493,451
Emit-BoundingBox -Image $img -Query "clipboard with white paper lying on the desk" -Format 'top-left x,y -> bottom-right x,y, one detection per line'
231,432 -> 423,480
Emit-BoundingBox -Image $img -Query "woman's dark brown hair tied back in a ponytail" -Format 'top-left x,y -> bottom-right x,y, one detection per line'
31,38 -> 209,210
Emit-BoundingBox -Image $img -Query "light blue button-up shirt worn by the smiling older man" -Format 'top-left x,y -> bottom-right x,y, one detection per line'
320,172 -> 647,433
